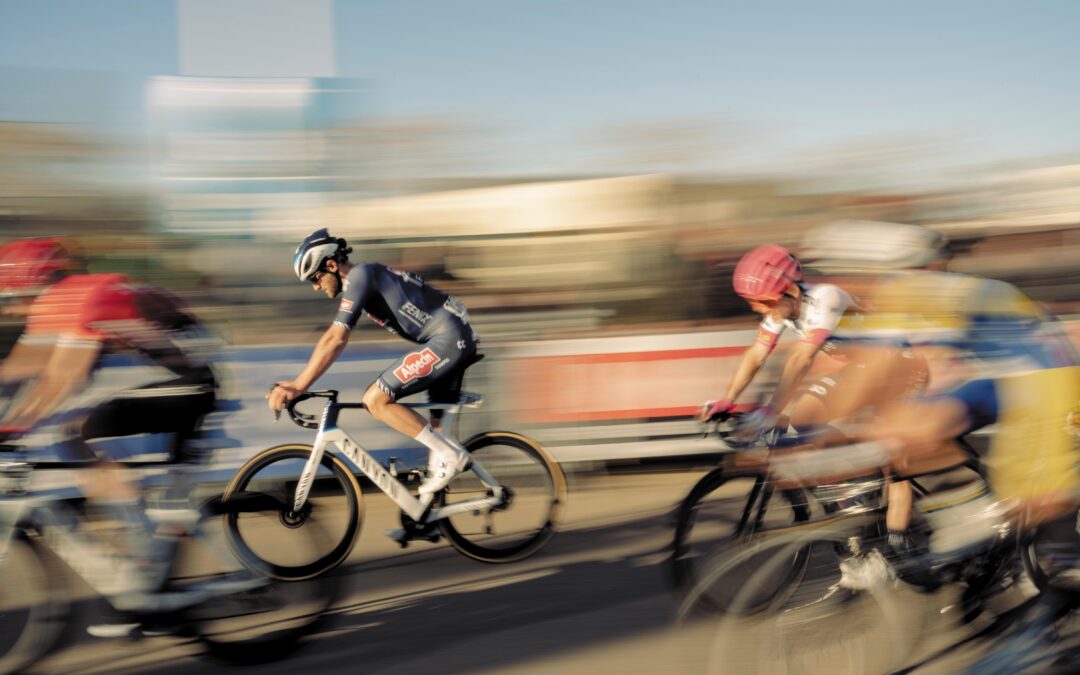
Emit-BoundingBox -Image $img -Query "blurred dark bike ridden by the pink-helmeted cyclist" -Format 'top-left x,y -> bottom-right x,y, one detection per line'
671,408 -> 1023,615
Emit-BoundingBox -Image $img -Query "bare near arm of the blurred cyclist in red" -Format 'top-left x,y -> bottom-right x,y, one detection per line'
4,341 -> 102,427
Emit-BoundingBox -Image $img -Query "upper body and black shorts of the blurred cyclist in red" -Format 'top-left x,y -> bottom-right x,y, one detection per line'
0,240 -> 216,461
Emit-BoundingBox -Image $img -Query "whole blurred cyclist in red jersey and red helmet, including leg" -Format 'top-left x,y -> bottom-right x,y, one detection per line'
0,239 -> 217,626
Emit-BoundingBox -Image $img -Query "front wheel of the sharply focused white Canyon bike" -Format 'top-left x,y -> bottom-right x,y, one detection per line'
221,444 -> 363,581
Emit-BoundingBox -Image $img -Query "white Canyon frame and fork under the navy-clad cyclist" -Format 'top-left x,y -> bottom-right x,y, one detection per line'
293,394 -> 505,523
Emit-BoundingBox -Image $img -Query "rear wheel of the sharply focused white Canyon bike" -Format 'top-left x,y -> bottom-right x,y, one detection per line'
437,431 -> 566,563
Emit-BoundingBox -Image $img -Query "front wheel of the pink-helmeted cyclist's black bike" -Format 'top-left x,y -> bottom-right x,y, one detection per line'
671,469 -> 810,613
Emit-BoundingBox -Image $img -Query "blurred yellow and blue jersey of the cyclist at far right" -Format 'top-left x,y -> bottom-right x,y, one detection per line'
841,272 -> 1080,502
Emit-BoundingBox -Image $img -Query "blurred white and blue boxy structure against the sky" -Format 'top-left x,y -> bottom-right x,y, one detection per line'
147,77 -> 364,237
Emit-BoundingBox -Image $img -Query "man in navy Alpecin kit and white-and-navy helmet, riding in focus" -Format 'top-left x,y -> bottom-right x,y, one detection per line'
267,229 -> 478,495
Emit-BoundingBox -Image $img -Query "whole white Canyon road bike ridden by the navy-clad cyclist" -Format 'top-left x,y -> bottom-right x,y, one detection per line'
224,390 -> 566,580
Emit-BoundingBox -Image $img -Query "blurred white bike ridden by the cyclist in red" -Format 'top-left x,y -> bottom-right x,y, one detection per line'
0,432 -> 339,673
